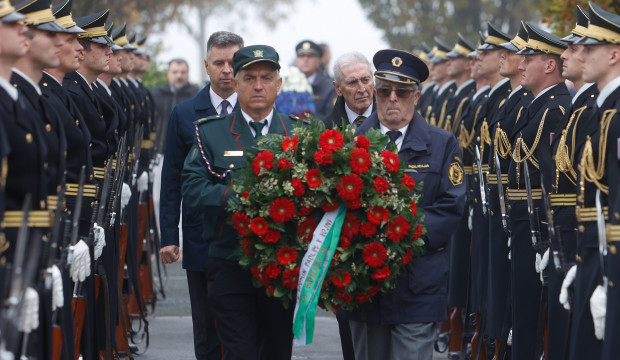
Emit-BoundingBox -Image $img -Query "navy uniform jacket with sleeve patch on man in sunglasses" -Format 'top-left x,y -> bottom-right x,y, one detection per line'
343,112 -> 465,325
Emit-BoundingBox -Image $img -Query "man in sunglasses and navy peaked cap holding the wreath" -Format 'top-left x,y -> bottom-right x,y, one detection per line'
347,50 -> 465,360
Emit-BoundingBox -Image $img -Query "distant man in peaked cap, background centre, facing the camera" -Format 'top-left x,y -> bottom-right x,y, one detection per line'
295,40 -> 337,120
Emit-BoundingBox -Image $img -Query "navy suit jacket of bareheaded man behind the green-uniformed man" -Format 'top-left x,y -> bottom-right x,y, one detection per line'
159,85 -> 238,271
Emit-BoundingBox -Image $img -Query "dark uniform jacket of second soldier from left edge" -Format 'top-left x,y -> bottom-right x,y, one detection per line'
11,73 -> 67,195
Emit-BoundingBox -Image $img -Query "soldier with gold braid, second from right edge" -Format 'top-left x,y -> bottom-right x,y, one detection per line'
543,5 -> 598,360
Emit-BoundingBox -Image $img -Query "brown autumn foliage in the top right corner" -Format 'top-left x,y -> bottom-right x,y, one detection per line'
539,0 -> 620,36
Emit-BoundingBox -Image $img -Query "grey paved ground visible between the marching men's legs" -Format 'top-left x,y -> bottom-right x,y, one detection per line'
136,263 -> 447,360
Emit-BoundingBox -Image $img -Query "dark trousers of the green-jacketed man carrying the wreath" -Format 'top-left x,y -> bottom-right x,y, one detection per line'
207,257 -> 295,360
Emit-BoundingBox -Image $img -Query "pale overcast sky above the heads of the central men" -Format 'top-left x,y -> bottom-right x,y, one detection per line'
151,0 -> 387,83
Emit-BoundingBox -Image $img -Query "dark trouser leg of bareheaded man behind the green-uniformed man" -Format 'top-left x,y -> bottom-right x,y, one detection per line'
186,270 -> 222,360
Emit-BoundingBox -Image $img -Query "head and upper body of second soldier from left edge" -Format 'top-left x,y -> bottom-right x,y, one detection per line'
11,0 -> 67,210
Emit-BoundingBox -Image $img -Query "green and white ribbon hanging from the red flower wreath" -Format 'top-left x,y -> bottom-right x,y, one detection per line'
293,204 -> 347,346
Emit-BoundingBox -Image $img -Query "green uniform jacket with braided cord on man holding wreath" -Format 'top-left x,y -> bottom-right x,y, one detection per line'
182,109 -> 297,260
